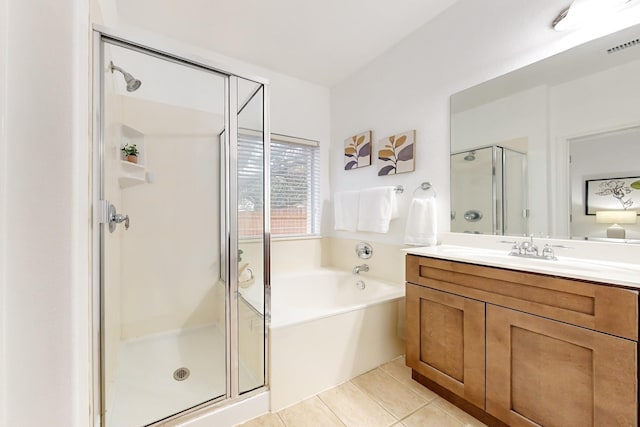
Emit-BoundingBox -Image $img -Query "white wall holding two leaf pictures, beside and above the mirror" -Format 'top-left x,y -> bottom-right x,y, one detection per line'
329,0 -> 638,243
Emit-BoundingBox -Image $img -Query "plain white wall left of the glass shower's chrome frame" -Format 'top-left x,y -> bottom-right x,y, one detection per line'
0,0 -> 91,427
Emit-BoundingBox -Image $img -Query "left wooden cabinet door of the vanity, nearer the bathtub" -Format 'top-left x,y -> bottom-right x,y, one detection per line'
406,283 -> 485,409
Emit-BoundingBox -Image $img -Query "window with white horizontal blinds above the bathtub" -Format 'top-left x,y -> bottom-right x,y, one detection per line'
238,134 -> 320,237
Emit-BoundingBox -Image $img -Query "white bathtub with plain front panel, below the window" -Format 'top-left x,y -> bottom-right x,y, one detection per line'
270,269 -> 404,411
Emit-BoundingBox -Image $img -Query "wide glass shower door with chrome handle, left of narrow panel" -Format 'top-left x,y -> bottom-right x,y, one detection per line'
100,42 -> 229,427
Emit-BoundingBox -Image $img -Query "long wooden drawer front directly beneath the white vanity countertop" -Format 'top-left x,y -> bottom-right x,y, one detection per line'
406,255 -> 638,341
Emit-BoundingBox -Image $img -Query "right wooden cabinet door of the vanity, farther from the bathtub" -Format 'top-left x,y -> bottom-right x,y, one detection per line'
486,304 -> 638,427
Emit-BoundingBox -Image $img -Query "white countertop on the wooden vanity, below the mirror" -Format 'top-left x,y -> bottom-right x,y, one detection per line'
404,245 -> 640,290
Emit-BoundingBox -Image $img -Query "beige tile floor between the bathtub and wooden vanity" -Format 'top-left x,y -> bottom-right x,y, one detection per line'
241,357 -> 486,427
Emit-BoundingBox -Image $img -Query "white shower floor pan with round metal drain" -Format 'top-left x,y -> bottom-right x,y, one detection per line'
106,326 -> 253,427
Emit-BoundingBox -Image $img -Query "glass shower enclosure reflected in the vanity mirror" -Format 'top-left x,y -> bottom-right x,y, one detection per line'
451,145 -> 528,235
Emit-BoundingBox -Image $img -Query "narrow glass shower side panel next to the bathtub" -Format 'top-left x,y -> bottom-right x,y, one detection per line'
235,79 -> 269,394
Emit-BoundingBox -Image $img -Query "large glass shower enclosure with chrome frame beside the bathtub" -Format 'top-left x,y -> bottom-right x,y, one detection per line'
93,32 -> 269,427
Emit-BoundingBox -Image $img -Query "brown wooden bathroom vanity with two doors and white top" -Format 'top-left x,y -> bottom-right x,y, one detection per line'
406,247 -> 638,427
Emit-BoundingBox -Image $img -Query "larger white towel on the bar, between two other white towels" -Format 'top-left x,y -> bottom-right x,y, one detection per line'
358,187 -> 398,233
